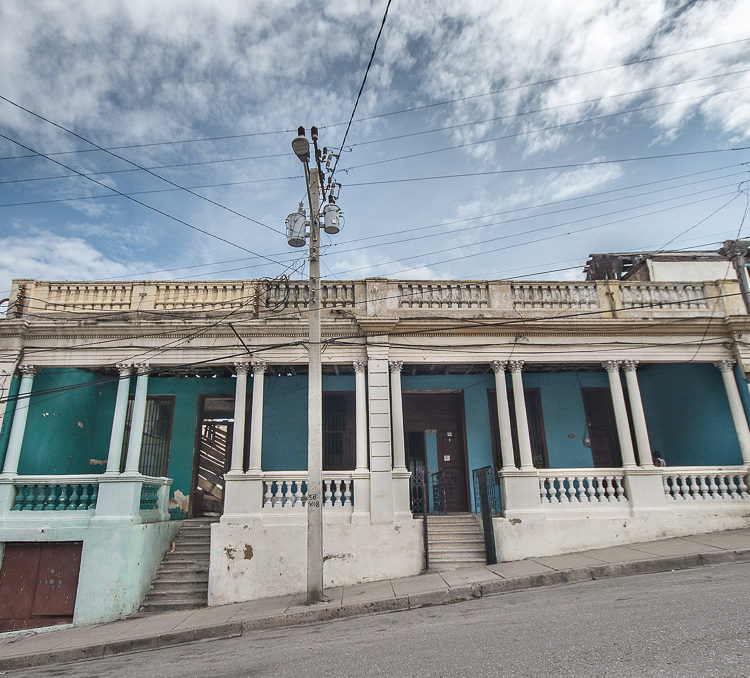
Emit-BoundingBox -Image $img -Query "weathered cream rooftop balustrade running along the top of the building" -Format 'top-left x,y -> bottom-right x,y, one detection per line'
11,280 -> 742,317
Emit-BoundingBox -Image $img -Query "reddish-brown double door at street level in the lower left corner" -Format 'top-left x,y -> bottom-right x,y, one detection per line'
0,542 -> 82,631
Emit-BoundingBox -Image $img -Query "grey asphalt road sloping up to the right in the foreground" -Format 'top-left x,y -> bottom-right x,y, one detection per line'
6,564 -> 750,678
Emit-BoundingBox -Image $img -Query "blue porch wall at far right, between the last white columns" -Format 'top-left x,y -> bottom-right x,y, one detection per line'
638,363 -> 742,466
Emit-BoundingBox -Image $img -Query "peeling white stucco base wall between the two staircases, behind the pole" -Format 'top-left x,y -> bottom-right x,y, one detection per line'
208,515 -> 424,605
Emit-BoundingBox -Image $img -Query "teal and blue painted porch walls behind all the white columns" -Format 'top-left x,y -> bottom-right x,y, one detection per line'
5,364 -> 750,516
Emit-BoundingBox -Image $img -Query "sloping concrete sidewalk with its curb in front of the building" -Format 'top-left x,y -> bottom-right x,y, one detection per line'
0,529 -> 750,672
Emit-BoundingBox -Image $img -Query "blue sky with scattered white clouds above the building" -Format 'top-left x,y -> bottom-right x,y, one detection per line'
0,0 -> 750,296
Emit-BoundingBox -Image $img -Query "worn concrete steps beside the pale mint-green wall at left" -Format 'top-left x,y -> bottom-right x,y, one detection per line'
141,518 -> 217,613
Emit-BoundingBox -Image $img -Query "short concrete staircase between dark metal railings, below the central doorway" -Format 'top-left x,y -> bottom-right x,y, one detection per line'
427,513 -> 487,572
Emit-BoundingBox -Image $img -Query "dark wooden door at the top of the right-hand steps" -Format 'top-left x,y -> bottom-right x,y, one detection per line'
403,392 -> 469,512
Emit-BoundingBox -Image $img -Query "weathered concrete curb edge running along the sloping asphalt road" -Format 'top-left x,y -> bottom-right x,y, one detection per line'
2,548 -> 750,671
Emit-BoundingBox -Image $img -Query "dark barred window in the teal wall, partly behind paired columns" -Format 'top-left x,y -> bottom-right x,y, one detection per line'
120,396 -> 174,477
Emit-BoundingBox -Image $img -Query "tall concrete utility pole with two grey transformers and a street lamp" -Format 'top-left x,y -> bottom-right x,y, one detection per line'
286,127 -> 340,605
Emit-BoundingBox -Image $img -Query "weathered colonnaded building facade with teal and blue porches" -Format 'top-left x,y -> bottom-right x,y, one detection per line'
0,278 -> 750,623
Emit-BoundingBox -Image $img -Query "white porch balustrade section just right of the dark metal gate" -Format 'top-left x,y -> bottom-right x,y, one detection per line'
539,469 -> 628,505
